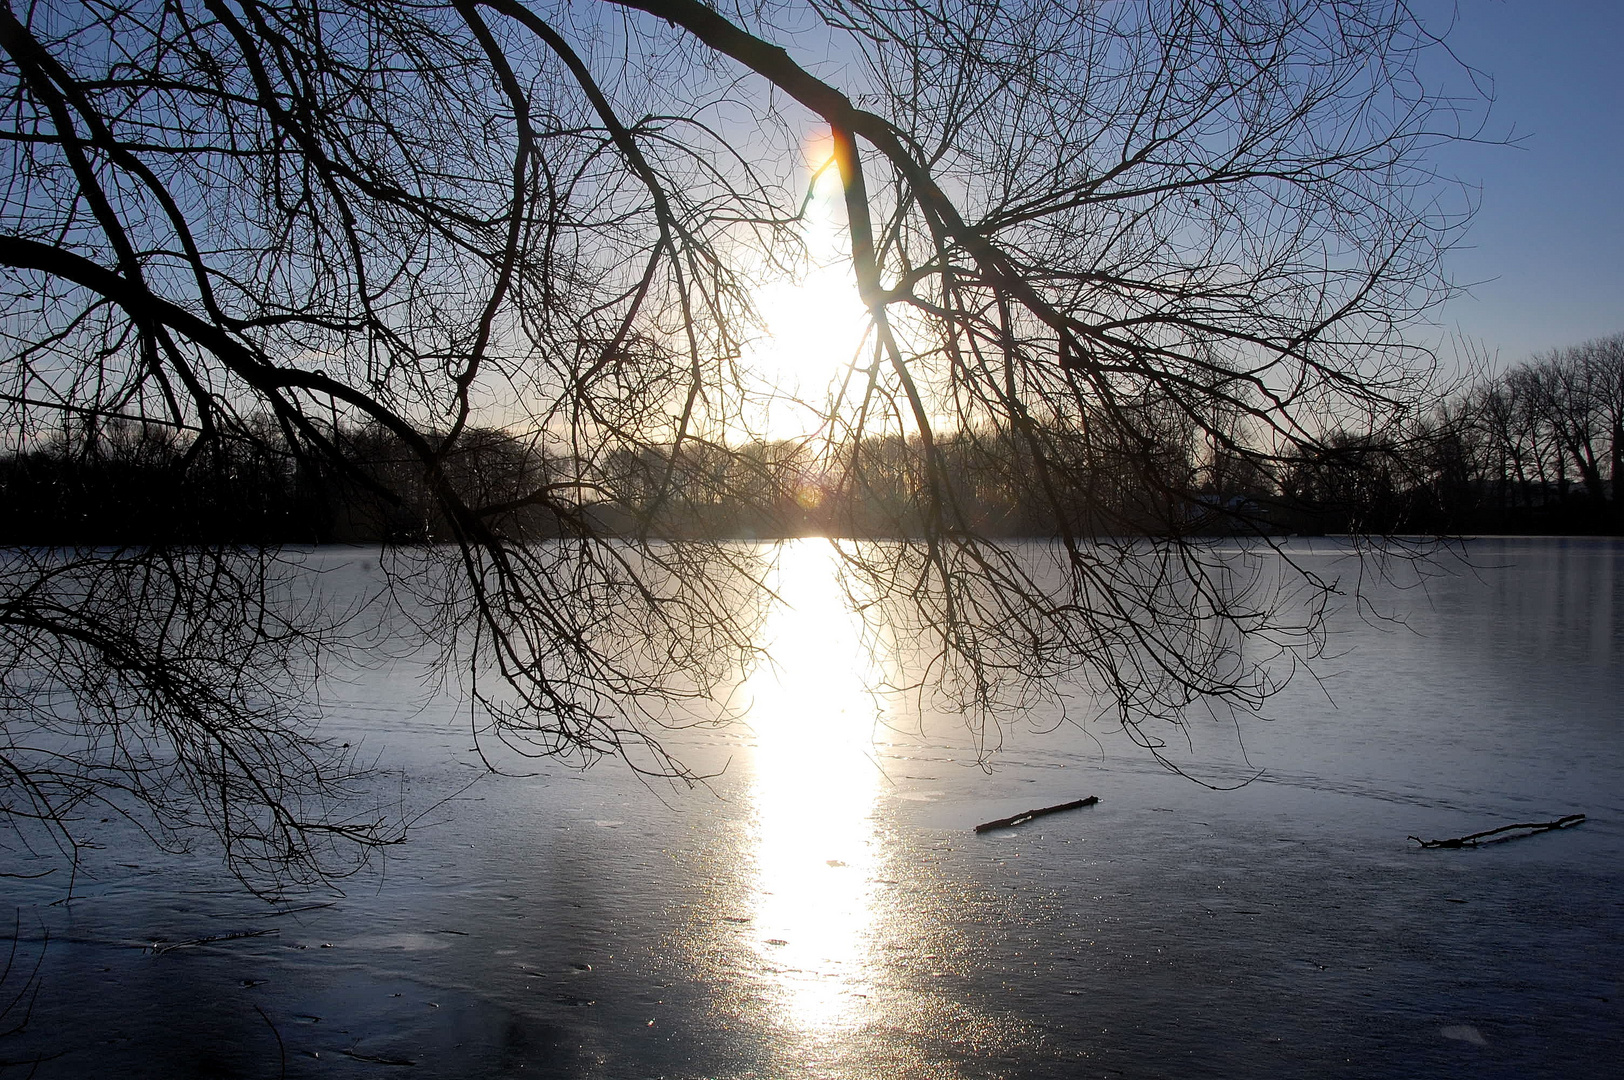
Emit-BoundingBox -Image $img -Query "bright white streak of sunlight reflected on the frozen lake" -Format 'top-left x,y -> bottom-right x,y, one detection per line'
744,539 -> 882,1035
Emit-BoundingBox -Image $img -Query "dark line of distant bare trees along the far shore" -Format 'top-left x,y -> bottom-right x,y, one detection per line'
0,335 -> 1624,546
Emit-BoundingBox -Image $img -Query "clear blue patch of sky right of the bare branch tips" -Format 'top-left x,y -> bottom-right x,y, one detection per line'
1419,0 -> 1624,367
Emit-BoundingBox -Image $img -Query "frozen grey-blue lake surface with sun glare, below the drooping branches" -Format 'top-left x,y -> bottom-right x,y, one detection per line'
0,539 -> 1624,1080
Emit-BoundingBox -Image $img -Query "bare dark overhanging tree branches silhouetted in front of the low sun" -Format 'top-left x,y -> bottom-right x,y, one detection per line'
0,0 -> 1460,883
